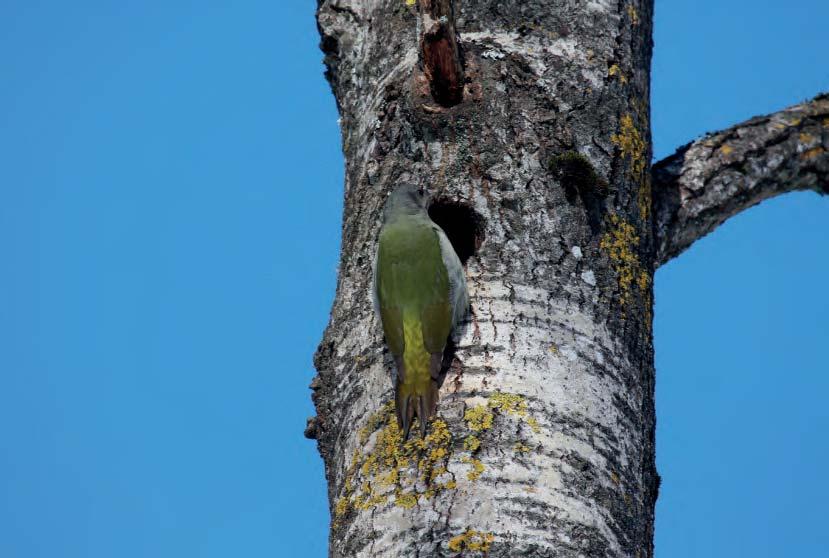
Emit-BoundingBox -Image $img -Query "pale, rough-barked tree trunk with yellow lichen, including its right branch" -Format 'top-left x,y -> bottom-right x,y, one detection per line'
306,0 -> 829,558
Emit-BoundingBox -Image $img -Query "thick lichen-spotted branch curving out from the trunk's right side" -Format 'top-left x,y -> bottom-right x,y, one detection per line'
653,94 -> 829,265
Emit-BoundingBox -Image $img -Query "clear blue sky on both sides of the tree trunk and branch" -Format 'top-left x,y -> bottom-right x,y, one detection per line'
0,0 -> 829,558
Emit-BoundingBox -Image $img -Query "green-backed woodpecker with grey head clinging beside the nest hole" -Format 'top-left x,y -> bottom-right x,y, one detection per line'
375,187 -> 467,437
